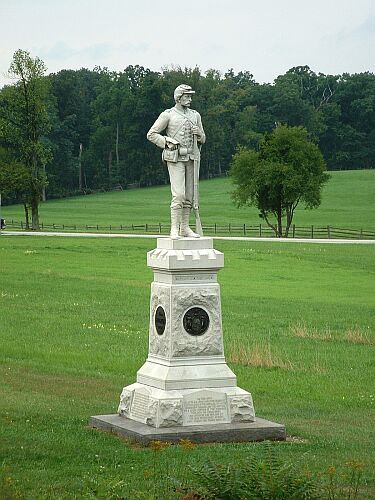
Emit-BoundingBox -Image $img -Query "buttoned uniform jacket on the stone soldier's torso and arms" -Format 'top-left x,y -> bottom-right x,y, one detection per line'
147,107 -> 206,161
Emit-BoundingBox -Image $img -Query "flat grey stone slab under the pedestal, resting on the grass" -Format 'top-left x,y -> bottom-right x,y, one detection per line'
89,415 -> 286,445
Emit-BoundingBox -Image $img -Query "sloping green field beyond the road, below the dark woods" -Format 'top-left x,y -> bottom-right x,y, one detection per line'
2,170 -> 375,231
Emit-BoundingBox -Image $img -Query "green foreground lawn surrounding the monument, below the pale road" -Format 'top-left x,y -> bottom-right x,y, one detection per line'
0,236 -> 375,499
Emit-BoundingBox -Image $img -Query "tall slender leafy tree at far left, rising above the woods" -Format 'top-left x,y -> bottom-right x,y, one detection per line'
0,50 -> 50,230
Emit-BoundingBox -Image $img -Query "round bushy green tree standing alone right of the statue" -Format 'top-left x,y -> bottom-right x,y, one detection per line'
230,125 -> 329,237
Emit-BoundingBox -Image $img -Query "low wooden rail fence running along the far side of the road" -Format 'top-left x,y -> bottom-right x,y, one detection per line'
3,220 -> 375,240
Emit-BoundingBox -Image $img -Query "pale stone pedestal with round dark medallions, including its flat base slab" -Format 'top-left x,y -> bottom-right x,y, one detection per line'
91,238 -> 285,441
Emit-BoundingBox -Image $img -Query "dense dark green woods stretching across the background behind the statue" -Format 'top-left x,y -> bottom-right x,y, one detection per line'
0,51 -> 375,223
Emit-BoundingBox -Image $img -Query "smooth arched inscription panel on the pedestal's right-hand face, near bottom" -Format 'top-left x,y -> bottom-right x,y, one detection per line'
183,391 -> 230,425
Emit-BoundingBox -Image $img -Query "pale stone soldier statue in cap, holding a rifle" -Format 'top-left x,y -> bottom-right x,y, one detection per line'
147,85 -> 206,239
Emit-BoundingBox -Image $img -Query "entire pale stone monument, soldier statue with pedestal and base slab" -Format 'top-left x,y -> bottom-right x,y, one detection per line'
90,85 -> 285,443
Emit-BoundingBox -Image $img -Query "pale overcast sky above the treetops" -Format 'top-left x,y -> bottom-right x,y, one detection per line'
0,0 -> 375,87
